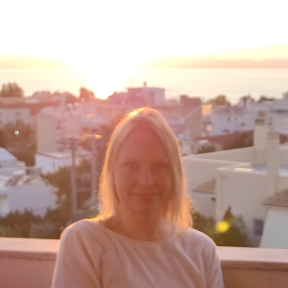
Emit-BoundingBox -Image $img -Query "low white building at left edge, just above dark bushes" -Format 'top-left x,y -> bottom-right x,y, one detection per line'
0,169 -> 56,217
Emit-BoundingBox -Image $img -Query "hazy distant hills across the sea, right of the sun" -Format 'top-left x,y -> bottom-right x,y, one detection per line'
137,57 -> 288,69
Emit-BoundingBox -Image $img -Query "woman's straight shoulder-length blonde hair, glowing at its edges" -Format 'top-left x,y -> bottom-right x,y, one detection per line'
96,108 -> 192,228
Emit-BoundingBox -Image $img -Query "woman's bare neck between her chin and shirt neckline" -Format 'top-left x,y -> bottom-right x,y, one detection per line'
111,213 -> 173,241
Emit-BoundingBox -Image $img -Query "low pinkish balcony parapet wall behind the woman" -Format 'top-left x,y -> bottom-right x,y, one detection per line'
0,238 -> 288,288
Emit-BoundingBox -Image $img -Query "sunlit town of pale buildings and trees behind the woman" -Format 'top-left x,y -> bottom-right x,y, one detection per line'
0,82 -> 288,248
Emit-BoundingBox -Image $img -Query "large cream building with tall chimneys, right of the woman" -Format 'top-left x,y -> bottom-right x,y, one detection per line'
183,112 -> 288,248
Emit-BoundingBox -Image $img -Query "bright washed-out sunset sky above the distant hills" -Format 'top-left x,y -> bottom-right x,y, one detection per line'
0,0 -> 288,97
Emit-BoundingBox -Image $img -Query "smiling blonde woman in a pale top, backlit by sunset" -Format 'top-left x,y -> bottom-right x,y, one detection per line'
52,108 -> 224,288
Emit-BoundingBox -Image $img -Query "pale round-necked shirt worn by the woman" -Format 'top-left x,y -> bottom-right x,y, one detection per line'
52,219 -> 224,288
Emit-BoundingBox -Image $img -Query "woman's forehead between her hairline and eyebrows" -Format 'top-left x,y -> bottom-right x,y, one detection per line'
117,129 -> 168,160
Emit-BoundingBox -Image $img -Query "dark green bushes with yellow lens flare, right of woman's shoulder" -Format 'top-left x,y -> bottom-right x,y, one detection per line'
193,206 -> 251,247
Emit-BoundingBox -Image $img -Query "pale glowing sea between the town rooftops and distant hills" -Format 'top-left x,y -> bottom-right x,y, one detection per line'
0,68 -> 288,104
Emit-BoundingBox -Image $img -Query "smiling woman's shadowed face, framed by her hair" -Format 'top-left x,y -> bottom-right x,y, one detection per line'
113,130 -> 172,213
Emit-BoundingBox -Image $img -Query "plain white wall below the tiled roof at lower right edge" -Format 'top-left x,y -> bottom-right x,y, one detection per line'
260,207 -> 288,249
